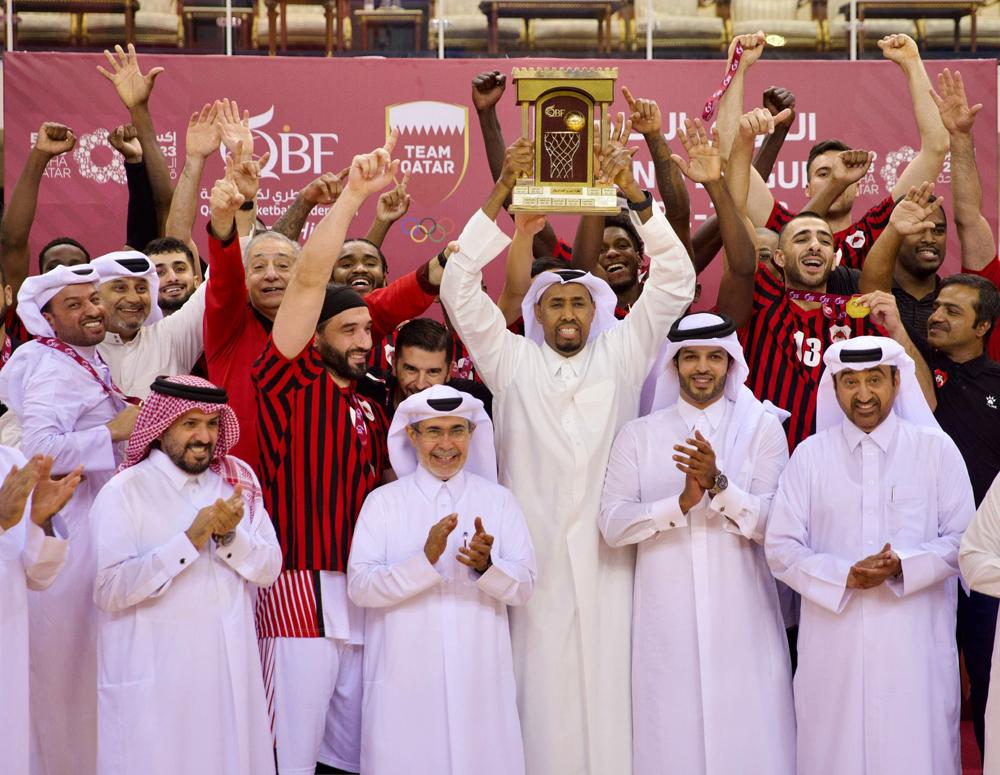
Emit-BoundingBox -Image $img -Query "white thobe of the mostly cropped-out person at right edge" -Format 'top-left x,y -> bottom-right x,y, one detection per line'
958,470 -> 1000,775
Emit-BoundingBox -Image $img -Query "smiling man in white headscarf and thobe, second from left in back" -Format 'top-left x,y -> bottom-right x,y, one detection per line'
90,250 -> 207,398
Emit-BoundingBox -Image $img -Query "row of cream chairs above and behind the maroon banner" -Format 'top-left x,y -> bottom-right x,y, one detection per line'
14,0 -> 1000,52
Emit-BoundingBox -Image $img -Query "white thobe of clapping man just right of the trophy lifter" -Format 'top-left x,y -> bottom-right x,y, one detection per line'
600,396 -> 795,775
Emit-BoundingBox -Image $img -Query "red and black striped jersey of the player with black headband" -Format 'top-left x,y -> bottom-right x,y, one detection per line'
252,338 -> 388,572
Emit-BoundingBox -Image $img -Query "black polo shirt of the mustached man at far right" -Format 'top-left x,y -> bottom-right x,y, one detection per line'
914,341 -> 1000,507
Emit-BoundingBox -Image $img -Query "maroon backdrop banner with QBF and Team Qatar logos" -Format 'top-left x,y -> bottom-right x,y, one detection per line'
4,52 -> 997,305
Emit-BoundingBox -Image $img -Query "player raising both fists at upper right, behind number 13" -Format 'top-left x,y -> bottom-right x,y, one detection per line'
718,34 -> 948,268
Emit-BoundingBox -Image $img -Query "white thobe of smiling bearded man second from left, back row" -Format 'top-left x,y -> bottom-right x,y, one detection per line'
97,283 -> 208,398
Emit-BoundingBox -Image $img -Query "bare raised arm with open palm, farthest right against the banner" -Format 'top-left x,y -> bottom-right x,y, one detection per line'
931,68 -> 997,271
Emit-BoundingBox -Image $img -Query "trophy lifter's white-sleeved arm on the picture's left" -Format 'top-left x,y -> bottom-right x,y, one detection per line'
441,138 -> 534,395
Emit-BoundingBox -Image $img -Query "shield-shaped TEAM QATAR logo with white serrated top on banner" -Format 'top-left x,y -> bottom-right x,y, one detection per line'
385,100 -> 469,207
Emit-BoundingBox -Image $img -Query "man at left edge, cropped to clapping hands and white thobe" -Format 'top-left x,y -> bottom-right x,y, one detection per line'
0,447 -> 81,774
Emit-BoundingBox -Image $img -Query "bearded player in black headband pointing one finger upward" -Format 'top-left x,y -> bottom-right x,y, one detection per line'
252,136 -> 399,775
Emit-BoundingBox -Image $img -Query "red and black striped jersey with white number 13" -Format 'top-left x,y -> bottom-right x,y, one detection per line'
739,265 -> 882,450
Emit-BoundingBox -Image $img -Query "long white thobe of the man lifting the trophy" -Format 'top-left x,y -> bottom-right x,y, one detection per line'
441,208 -> 695,775
